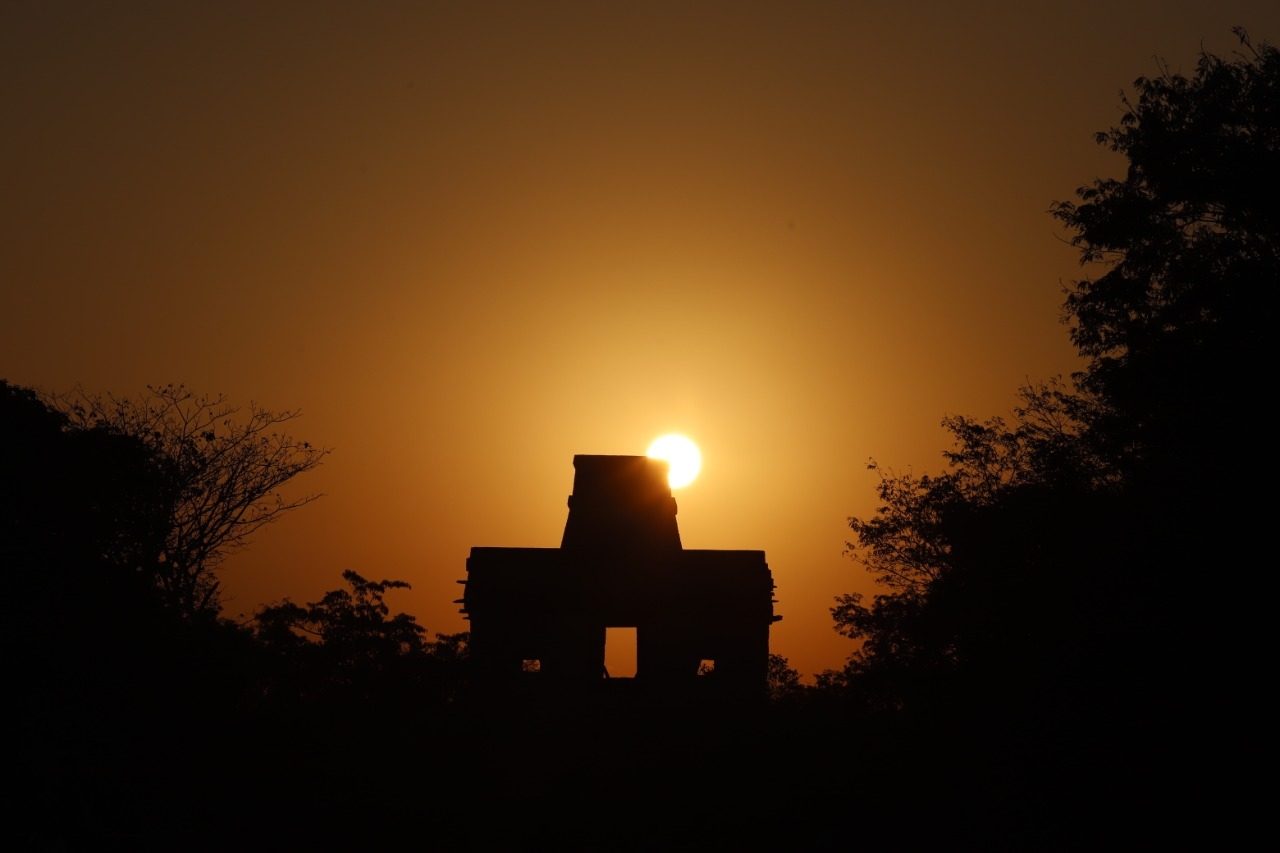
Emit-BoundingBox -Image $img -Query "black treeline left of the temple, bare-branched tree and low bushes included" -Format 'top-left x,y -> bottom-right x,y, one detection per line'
0,380 -> 476,704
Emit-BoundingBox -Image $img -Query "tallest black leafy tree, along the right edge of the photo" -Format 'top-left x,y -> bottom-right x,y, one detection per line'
1052,28 -> 1280,695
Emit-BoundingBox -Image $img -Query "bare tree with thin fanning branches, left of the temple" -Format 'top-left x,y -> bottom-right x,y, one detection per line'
50,384 -> 329,617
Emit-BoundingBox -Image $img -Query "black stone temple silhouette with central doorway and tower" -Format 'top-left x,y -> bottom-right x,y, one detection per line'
457,456 -> 782,698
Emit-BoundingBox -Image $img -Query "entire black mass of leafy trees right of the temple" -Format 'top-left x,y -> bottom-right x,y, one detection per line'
819,31 -> 1280,719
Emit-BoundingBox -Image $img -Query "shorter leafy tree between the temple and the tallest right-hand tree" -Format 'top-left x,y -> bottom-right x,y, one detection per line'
832,380 -> 1115,707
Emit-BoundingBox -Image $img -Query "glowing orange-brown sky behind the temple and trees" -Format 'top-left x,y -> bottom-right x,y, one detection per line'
0,0 -> 1280,676
